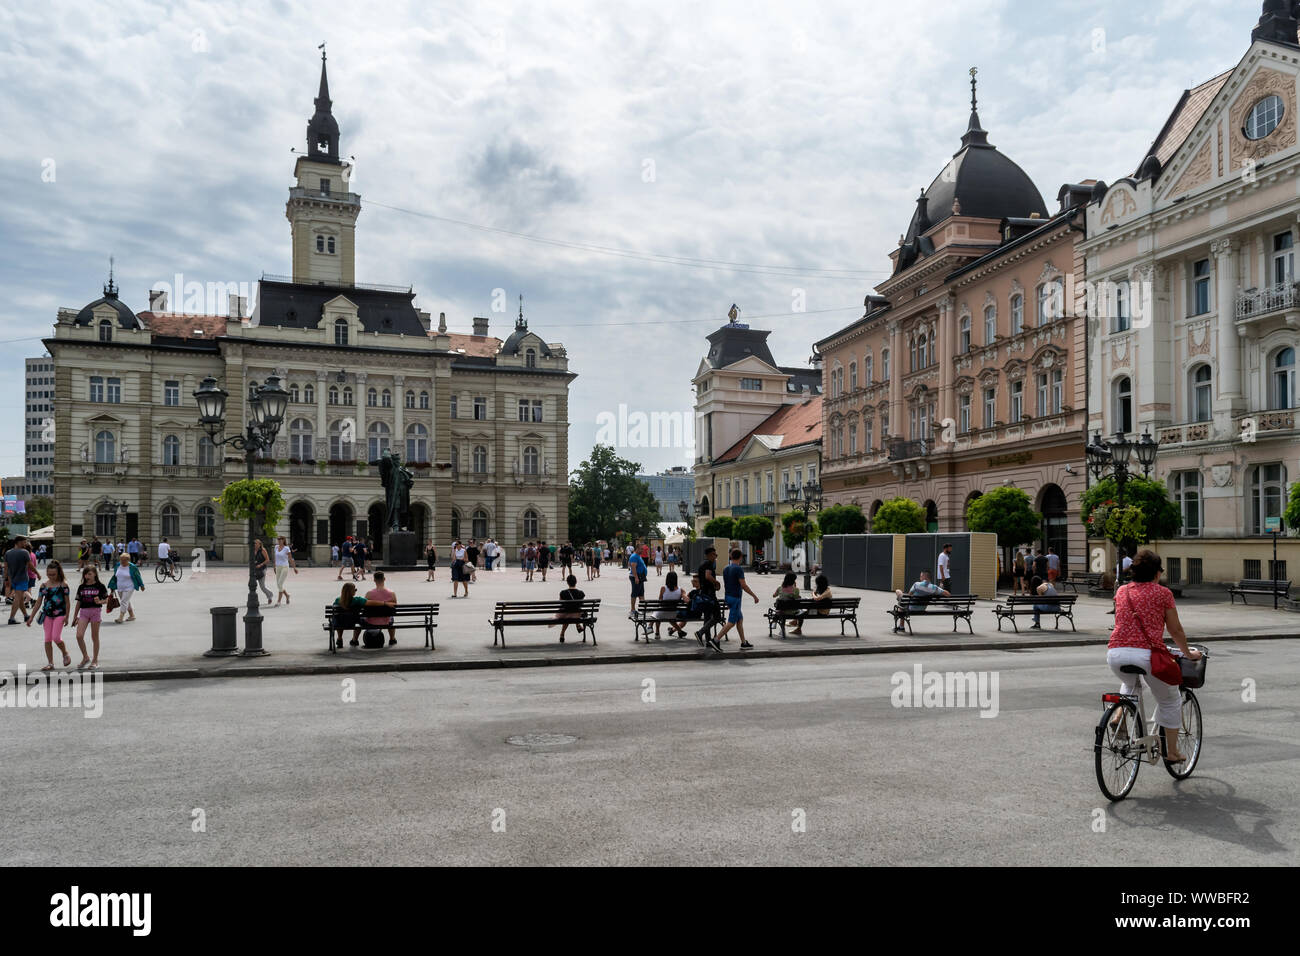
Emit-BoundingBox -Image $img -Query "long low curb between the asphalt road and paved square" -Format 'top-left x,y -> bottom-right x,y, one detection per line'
71,633 -> 1300,683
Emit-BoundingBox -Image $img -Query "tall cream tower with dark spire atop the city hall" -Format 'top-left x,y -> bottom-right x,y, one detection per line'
285,49 -> 361,285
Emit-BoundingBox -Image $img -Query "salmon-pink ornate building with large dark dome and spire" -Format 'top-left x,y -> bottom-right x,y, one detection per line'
815,83 -> 1092,568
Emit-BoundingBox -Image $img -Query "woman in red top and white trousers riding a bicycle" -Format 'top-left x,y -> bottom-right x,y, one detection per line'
1106,549 -> 1201,763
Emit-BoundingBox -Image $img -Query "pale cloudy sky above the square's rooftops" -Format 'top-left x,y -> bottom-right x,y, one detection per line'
0,0 -> 1260,475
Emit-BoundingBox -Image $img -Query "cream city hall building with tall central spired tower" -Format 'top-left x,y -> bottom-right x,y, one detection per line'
46,57 -> 575,562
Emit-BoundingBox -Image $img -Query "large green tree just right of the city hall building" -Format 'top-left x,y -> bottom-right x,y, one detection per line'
569,445 -> 659,541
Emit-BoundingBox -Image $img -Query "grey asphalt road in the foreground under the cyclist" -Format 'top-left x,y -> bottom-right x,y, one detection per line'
0,641 -> 1300,866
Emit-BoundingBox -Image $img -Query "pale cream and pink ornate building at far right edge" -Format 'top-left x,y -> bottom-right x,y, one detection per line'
1080,3 -> 1300,584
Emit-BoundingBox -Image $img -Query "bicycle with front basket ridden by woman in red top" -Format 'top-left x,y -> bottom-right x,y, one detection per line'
1093,645 -> 1209,803
